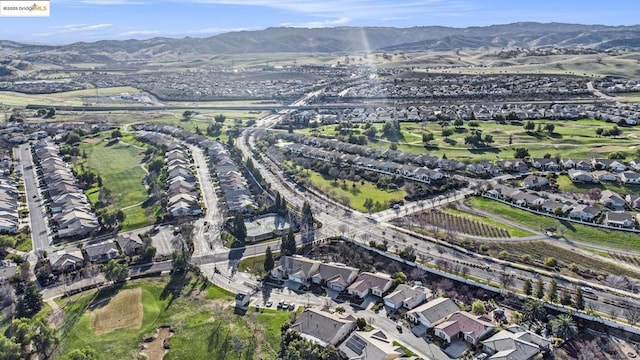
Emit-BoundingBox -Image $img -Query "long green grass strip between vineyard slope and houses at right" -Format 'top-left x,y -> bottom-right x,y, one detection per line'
467,197 -> 640,252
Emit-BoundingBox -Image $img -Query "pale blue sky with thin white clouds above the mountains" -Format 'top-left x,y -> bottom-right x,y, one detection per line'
0,0 -> 640,44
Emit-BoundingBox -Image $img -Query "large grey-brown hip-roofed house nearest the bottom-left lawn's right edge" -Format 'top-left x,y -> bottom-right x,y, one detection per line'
289,308 -> 356,346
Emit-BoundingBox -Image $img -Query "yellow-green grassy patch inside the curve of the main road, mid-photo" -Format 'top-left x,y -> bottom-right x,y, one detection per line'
304,170 -> 407,212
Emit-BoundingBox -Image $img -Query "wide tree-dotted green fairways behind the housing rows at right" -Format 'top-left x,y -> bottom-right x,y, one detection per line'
297,119 -> 640,160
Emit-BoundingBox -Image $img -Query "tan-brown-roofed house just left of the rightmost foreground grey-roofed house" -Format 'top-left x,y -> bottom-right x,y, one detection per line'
434,311 -> 495,345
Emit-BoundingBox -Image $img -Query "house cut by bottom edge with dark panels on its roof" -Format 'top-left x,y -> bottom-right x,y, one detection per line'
338,330 -> 404,360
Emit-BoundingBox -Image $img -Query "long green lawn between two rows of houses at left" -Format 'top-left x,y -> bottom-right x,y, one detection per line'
80,138 -> 155,231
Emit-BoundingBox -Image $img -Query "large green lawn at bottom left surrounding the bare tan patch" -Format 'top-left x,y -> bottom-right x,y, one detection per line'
58,276 -> 289,360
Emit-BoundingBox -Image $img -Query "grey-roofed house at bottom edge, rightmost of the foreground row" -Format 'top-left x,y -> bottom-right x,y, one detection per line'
482,325 -> 551,360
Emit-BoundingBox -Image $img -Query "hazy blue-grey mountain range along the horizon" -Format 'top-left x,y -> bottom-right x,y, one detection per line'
0,22 -> 640,62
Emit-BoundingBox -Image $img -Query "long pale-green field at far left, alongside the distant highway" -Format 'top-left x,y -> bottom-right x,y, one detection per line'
0,86 -> 142,107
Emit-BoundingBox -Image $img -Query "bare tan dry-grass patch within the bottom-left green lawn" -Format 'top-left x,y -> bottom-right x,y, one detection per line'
91,288 -> 143,335
